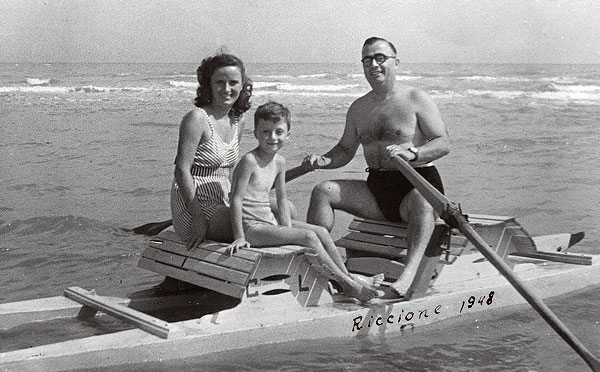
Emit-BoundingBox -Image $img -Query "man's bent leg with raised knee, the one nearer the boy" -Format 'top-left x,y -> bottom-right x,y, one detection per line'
306,180 -> 385,231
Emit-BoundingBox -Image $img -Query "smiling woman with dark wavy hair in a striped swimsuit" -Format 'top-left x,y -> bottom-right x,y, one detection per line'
171,54 -> 252,249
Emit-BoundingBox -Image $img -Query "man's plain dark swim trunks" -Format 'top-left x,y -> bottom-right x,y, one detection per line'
367,166 -> 444,222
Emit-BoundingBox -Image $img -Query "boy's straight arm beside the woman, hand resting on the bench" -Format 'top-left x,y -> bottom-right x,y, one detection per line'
228,156 -> 254,254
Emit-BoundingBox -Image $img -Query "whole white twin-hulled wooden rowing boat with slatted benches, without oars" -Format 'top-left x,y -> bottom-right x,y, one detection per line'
0,215 -> 600,371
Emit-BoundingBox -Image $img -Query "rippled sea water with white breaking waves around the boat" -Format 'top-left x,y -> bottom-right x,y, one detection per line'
0,63 -> 600,371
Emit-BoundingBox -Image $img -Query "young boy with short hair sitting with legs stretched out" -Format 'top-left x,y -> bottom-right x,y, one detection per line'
229,102 -> 383,301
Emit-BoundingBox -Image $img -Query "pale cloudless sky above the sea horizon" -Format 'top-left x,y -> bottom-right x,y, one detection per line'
0,0 -> 600,63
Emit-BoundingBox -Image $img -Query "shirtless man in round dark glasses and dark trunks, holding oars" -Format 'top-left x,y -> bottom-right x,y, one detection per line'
302,37 -> 450,297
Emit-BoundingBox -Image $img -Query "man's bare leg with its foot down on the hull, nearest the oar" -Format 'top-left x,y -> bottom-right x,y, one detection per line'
392,189 -> 437,296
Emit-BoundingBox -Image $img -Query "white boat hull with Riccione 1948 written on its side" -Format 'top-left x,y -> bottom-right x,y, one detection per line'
0,254 -> 600,372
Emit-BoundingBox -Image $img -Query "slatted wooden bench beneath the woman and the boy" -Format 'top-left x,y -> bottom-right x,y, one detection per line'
138,230 -> 328,306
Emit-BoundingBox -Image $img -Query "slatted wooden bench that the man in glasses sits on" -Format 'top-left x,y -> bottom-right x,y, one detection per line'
335,215 -> 535,298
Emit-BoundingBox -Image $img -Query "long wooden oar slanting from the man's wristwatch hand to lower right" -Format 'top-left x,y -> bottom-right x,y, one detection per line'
393,156 -> 600,372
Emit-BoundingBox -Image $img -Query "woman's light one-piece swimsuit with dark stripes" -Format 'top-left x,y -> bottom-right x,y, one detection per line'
171,109 -> 240,241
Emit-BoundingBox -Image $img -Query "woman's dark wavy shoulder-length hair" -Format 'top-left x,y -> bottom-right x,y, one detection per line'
194,54 -> 252,117
